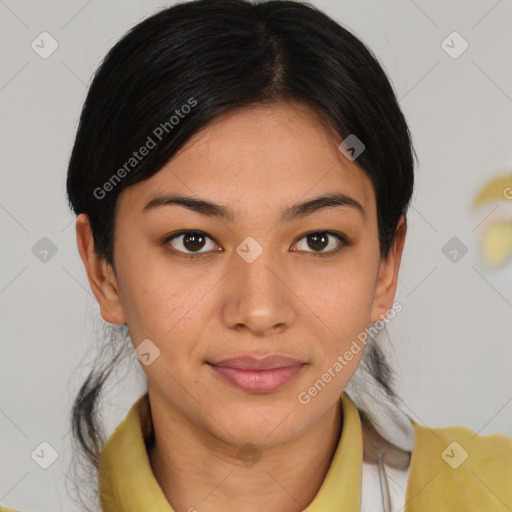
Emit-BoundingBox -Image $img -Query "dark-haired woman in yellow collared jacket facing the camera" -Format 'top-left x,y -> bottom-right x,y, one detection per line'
3,0 -> 512,512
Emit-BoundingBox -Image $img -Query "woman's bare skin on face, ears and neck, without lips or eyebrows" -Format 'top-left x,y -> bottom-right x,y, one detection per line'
76,103 -> 406,512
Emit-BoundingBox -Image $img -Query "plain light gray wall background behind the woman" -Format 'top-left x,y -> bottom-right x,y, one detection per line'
0,0 -> 512,511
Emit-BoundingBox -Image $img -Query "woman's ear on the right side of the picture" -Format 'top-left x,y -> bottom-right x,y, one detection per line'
371,215 -> 407,322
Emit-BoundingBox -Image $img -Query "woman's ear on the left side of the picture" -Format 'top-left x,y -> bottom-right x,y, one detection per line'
75,213 -> 126,324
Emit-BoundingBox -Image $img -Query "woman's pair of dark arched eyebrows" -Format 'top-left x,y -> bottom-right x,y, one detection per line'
143,192 -> 366,222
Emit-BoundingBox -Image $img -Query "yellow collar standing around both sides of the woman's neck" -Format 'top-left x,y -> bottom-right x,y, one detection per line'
98,392 -> 363,512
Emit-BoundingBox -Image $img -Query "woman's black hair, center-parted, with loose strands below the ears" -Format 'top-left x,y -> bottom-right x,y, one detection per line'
67,0 -> 415,508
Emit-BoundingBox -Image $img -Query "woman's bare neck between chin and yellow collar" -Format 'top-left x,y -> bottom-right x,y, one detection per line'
148,396 -> 343,512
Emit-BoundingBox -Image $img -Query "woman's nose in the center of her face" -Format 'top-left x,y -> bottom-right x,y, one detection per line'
222,243 -> 296,337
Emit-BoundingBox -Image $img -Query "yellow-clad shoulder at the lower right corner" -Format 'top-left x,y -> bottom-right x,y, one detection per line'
409,421 -> 512,510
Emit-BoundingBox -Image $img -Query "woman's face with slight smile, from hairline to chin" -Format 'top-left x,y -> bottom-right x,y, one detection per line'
77,104 -> 405,446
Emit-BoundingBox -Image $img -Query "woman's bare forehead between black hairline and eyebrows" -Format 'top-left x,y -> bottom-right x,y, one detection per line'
119,103 -> 375,220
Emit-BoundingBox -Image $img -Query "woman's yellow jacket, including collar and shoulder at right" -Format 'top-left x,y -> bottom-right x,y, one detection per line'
0,393 -> 512,512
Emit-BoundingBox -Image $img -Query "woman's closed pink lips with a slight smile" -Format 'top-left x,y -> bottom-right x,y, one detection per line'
208,356 -> 306,393
